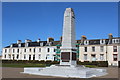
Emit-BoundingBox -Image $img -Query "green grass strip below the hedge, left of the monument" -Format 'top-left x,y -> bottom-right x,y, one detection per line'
2,63 -> 46,68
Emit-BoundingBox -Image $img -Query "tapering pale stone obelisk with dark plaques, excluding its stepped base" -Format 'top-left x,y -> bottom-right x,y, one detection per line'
60,8 -> 76,66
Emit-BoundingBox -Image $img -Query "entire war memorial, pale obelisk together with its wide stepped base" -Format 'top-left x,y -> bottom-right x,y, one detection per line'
23,8 -> 107,78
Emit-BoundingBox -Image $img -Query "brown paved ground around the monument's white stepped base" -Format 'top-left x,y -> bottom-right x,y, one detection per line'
2,67 -> 120,78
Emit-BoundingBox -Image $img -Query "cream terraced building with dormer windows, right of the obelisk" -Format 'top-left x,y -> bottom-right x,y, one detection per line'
79,34 -> 120,66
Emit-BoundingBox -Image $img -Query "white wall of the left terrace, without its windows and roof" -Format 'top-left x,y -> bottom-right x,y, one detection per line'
2,46 -> 56,61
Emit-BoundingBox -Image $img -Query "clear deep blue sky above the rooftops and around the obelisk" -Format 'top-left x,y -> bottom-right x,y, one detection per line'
2,2 -> 118,53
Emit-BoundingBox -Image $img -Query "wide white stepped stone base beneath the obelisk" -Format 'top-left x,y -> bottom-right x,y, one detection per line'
23,65 -> 107,78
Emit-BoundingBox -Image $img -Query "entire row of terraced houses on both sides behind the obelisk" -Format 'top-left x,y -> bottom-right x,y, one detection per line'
2,34 -> 120,66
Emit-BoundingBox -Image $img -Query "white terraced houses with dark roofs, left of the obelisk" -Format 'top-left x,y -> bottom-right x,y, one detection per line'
2,37 -> 56,61
